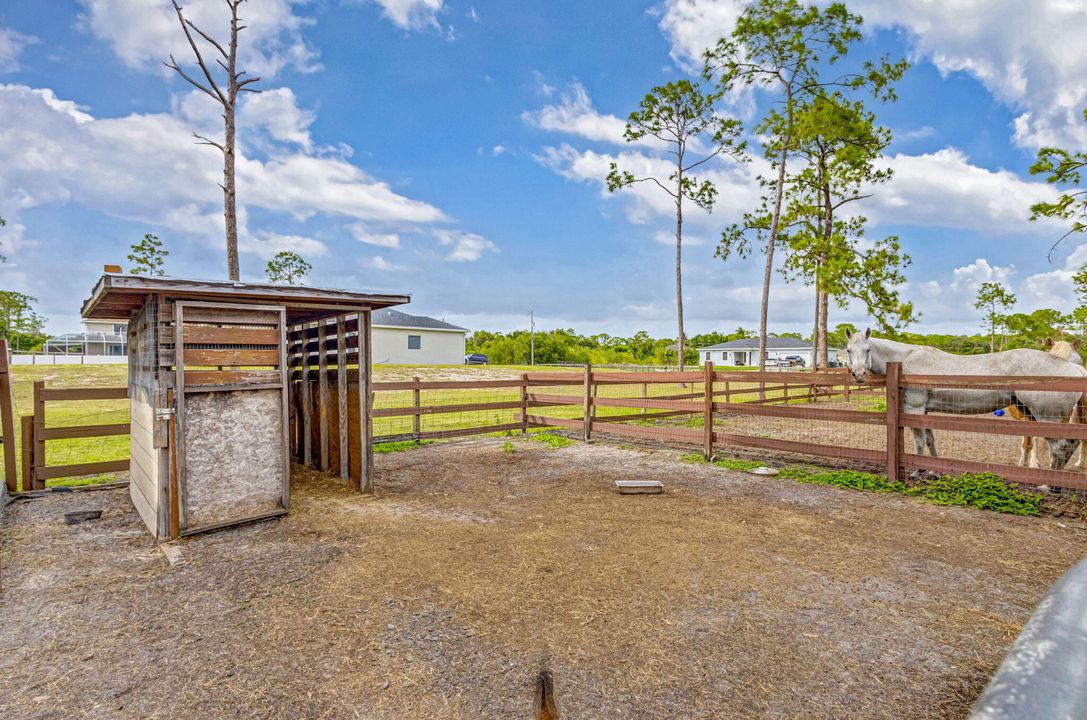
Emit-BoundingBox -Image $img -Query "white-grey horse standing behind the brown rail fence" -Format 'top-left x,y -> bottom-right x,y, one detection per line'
846,330 -> 1087,470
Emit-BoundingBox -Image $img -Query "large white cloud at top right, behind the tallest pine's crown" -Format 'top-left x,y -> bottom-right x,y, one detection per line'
654,0 -> 1087,148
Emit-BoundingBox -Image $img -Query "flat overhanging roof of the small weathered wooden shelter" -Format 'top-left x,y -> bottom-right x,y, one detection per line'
82,273 -> 411,322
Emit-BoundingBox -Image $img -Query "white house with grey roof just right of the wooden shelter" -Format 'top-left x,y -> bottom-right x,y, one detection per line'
371,308 -> 467,365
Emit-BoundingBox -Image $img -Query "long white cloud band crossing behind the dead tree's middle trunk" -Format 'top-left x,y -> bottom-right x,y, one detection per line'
0,85 -> 445,251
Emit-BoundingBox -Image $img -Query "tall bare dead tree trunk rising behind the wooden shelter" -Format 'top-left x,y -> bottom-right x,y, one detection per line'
165,0 -> 261,281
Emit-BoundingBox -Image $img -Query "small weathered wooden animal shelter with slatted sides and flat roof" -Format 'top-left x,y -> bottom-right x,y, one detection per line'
83,274 -> 410,538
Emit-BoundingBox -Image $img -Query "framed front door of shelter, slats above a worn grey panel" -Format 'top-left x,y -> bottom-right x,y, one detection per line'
173,300 -> 290,534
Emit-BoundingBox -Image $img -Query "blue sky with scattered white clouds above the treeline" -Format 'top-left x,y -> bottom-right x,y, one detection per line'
0,0 -> 1087,336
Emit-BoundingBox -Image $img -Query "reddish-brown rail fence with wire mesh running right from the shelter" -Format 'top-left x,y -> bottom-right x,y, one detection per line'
373,363 -> 1087,489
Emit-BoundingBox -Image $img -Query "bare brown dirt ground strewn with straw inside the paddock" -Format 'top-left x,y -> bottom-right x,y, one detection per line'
0,438 -> 1087,720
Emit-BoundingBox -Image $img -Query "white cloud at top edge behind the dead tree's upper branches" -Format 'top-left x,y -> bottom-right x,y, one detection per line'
80,0 -> 321,78
